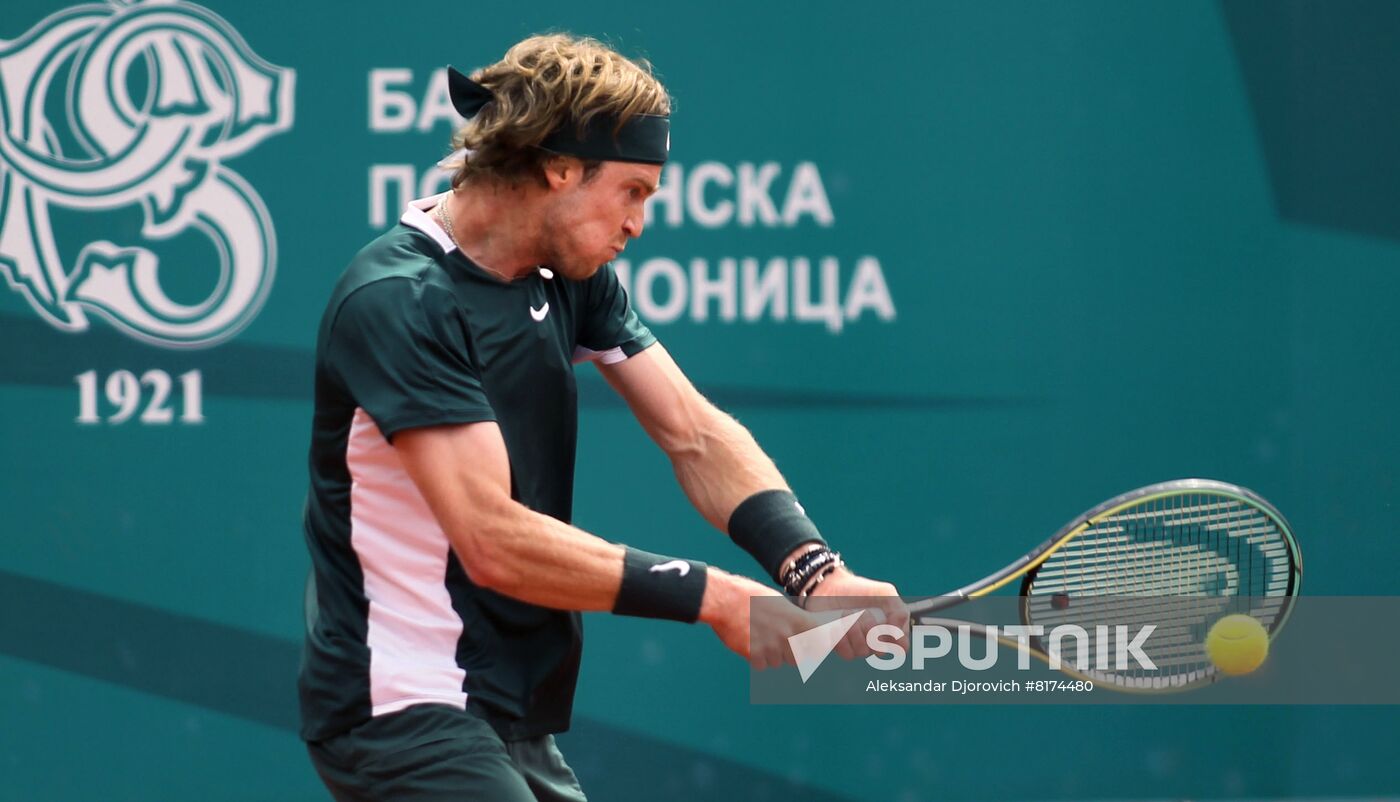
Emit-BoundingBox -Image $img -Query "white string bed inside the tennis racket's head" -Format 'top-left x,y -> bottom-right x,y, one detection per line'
1026,491 -> 1294,689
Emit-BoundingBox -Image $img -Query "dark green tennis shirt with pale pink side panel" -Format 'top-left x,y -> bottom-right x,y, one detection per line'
300,199 -> 655,740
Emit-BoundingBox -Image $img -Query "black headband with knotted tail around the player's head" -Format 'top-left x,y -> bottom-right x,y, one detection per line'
447,67 -> 671,164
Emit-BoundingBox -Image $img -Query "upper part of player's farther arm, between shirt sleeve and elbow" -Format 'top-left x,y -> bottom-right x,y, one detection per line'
598,343 -> 715,453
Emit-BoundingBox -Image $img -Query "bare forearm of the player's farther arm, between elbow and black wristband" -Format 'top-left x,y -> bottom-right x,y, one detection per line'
668,403 -> 788,532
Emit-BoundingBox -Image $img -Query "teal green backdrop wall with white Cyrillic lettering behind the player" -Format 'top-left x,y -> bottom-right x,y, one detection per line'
0,0 -> 1400,802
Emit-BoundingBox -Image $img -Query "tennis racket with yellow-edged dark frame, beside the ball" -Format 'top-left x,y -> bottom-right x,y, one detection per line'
909,479 -> 1302,693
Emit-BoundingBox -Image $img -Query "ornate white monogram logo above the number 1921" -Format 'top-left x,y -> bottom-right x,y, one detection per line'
0,1 -> 295,347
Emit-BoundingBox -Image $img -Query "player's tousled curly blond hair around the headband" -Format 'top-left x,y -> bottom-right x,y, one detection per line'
448,34 -> 671,188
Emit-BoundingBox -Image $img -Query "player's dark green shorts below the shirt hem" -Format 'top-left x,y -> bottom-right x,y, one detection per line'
307,704 -> 584,802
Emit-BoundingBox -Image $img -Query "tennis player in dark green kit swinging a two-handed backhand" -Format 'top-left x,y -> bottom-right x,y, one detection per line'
300,35 -> 907,802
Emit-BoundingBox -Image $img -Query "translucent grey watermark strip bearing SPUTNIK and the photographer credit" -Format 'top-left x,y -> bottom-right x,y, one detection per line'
749,593 -> 1400,699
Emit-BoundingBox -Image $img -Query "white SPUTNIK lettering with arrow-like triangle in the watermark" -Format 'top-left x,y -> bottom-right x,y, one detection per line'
788,612 -> 1156,684
